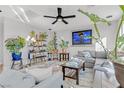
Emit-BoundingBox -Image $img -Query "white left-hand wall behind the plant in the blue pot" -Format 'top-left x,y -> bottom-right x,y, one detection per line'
4,18 -> 43,67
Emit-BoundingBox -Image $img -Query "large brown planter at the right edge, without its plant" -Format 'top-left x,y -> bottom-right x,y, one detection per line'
113,62 -> 124,88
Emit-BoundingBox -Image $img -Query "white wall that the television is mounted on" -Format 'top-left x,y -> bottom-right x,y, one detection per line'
53,21 -> 117,56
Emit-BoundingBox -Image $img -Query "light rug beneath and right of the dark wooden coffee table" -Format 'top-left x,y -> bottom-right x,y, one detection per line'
63,68 -> 93,88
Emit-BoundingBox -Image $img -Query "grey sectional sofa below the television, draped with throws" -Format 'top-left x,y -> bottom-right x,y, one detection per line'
74,50 -> 120,88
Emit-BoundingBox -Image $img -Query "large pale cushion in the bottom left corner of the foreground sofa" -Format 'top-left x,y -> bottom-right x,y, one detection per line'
0,69 -> 36,88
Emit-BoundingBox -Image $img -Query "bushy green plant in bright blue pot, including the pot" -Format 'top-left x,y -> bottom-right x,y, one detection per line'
5,36 -> 26,60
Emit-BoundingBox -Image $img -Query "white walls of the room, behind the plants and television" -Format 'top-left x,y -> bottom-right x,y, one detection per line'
3,18 -> 117,66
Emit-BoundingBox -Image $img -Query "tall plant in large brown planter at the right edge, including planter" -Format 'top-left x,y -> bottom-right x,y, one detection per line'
112,5 -> 124,87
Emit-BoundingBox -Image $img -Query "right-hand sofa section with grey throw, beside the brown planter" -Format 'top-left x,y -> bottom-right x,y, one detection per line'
92,59 -> 120,88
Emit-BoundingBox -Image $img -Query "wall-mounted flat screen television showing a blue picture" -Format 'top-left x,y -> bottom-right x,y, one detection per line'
72,29 -> 92,45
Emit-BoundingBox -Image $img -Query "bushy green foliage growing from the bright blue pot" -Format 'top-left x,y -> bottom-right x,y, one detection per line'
5,36 -> 26,53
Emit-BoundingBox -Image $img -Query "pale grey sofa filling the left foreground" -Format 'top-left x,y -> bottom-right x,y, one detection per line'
0,68 -> 63,88
